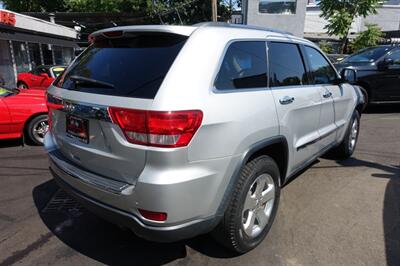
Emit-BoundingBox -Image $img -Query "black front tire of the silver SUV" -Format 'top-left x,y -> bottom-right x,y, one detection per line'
332,110 -> 360,160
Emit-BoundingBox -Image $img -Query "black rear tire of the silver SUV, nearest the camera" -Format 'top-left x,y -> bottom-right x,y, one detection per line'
212,155 -> 280,254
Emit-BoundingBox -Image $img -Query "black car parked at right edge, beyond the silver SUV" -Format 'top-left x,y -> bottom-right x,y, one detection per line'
335,45 -> 400,108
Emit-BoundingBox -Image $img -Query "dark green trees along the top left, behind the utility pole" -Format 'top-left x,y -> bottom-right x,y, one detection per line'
2,0 -> 233,24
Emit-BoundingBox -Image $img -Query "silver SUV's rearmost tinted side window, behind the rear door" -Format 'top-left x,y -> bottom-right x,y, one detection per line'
215,41 -> 267,90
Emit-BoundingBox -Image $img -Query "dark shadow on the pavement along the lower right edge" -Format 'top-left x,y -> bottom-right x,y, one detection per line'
337,158 -> 400,265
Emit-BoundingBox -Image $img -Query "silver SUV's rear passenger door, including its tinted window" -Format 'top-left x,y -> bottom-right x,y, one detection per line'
268,42 -> 321,170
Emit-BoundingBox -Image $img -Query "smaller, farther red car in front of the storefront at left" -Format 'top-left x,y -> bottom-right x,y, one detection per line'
17,65 -> 65,90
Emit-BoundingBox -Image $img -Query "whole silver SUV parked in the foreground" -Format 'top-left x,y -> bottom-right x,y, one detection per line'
45,23 -> 363,253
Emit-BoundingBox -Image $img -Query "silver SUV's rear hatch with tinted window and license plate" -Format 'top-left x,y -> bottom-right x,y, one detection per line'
48,31 -> 187,184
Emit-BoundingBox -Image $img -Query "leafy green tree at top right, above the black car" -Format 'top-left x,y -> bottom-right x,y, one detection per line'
320,0 -> 382,53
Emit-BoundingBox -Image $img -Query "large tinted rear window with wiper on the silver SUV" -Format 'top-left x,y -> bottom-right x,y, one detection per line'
55,34 -> 187,99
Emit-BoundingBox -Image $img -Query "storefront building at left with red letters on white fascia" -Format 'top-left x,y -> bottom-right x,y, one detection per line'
0,9 -> 78,87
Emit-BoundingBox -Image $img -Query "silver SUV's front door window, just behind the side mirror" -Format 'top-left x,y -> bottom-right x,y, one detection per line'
305,46 -> 337,84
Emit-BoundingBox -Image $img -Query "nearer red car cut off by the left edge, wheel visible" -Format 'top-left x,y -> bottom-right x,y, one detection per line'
0,87 -> 48,145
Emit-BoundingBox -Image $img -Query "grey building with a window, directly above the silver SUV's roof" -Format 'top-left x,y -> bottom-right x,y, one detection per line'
242,0 -> 307,37
